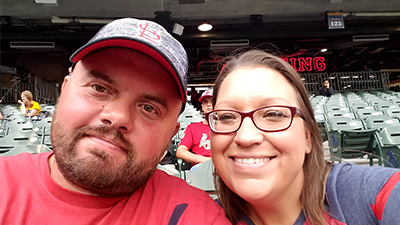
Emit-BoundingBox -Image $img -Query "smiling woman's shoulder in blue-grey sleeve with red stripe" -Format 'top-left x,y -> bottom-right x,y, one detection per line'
326,163 -> 400,224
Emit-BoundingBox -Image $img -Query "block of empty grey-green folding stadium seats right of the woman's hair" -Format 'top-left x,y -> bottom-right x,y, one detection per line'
311,92 -> 400,167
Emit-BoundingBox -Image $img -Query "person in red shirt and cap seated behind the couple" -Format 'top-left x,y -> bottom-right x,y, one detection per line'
176,89 -> 212,165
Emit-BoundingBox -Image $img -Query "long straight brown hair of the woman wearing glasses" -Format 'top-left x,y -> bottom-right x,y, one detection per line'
212,50 -> 330,225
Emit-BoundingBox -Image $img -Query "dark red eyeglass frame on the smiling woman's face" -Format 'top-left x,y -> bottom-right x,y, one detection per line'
205,105 -> 305,134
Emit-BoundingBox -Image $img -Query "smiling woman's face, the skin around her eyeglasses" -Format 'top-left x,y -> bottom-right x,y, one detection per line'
211,68 -> 311,206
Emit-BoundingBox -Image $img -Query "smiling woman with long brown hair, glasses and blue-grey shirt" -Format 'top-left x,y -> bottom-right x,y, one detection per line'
206,50 -> 400,225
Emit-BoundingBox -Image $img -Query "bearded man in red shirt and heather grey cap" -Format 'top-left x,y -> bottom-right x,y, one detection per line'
0,18 -> 228,225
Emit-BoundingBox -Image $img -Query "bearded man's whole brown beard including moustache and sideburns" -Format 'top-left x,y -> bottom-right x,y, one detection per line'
51,115 -> 166,197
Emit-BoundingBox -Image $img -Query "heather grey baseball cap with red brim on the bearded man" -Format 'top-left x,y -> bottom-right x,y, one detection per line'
70,18 -> 188,111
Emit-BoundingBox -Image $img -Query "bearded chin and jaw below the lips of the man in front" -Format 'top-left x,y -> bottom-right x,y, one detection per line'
56,149 -> 158,197
